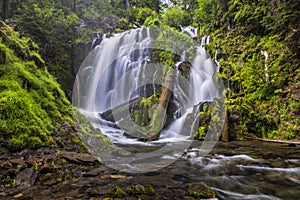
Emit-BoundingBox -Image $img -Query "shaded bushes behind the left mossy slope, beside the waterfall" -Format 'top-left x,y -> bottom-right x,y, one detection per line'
14,0 -> 79,91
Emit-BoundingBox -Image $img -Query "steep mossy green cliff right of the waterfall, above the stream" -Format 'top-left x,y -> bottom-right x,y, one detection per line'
195,0 -> 300,139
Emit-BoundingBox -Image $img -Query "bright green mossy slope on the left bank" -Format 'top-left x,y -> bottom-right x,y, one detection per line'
0,23 -> 72,150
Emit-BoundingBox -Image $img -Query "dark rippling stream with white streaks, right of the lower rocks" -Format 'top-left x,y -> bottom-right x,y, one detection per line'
180,141 -> 300,200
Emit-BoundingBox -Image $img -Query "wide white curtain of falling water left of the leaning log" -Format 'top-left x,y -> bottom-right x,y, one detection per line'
81,29 -> 151,112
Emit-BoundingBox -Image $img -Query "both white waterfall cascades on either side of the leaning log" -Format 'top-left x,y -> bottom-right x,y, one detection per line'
74,28 -> 219,145
